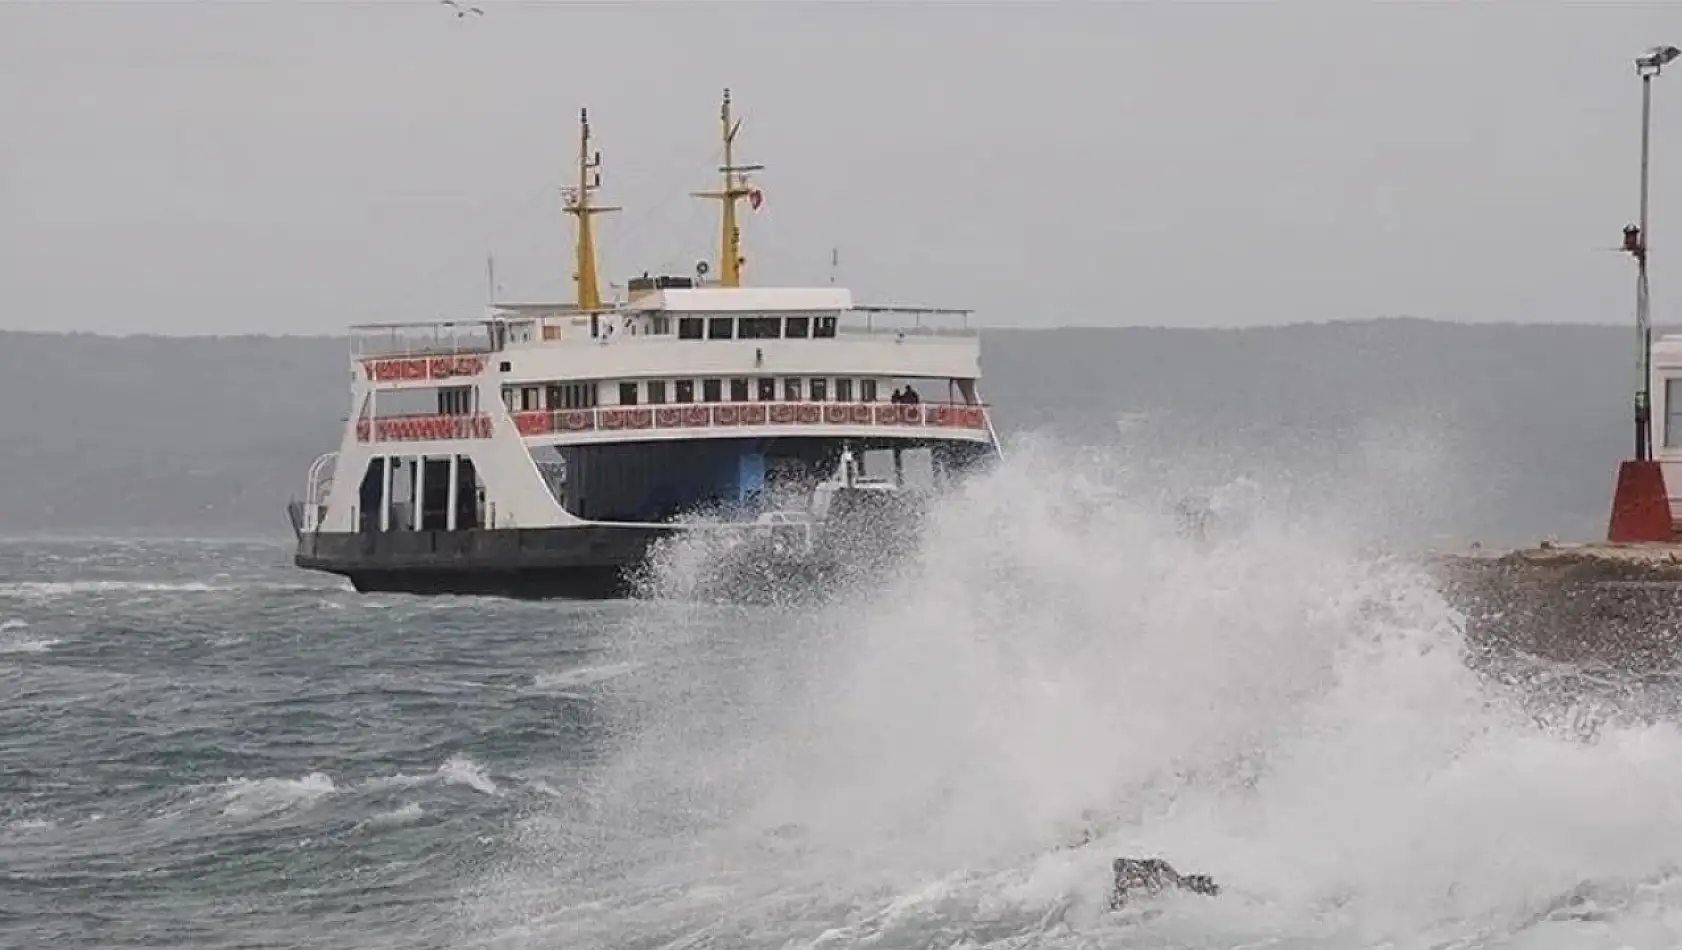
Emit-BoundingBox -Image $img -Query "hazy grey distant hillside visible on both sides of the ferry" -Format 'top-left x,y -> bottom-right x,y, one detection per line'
0,319 -> 1633,538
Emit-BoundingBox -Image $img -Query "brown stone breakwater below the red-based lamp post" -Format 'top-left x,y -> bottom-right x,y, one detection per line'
1428,543 -> 1682,673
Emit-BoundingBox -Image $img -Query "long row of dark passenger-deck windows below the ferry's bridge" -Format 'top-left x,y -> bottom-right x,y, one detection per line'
503,377 -> 878,412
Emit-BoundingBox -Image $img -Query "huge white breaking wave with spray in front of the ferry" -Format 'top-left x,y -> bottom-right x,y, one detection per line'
463,433 -> 1682,948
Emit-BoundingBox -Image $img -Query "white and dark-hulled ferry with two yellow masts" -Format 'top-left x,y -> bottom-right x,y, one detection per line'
288,89 -> 999,597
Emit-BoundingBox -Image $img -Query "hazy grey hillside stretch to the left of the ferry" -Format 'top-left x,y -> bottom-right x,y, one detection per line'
0,333 -> 350,535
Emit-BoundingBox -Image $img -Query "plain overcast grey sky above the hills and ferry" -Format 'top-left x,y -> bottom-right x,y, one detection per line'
0,0 -> 1682,333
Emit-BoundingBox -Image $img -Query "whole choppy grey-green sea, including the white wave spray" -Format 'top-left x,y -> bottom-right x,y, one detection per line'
0,447 -> 1682,950
